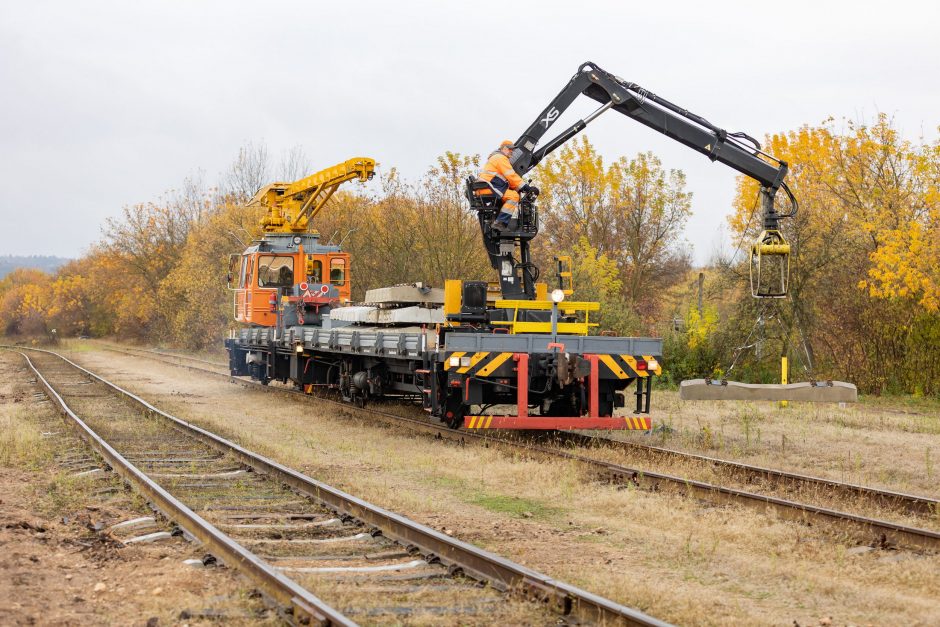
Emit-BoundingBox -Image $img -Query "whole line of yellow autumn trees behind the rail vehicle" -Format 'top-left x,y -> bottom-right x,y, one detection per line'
0,115 -> 940,394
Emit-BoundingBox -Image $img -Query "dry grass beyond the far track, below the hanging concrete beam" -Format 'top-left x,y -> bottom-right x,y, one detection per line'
615,391 -> 940,498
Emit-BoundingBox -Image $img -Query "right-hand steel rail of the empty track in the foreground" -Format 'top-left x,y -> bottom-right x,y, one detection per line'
24,349 -> 668,627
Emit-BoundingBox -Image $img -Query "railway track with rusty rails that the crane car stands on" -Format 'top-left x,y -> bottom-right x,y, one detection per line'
90,347 -> 940,552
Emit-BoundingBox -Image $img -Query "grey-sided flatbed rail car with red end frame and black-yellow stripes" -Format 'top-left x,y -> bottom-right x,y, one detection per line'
226,314 -> 662,430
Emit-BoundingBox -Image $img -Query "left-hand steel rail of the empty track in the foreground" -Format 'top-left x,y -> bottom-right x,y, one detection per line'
17,349 -> 356,626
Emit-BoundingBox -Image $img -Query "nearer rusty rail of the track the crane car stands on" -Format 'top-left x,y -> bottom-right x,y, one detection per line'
93,348 -> 940,552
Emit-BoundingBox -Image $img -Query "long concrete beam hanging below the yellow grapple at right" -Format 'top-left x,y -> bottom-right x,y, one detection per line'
679,379 -> 858,403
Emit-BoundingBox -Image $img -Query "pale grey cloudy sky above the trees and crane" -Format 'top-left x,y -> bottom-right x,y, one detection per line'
0,0 -> 940,261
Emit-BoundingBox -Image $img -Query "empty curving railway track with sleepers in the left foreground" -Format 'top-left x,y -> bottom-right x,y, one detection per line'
12,349 -> 666,625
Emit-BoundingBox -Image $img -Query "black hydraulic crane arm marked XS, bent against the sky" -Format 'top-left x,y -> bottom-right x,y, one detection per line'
510,62 -> 797,229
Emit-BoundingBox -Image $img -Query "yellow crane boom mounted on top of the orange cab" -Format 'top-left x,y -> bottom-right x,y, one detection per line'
248,157 -> 375,233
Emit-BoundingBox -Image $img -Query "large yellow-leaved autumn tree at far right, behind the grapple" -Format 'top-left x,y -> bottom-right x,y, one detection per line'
731,115 -> 940,390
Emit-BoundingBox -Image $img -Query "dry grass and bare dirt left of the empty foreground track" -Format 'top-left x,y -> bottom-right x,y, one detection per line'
0,352 -> 279,625
